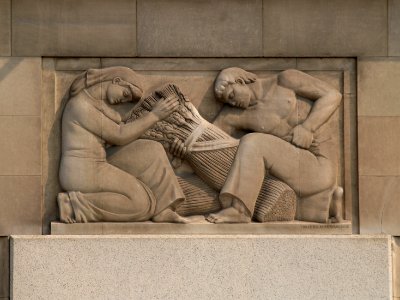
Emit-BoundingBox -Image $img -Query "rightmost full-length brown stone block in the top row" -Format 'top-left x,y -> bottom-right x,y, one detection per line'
263,0 -> 388,57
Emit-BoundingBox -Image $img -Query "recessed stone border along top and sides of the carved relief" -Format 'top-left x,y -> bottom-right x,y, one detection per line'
42,58 -> 359,233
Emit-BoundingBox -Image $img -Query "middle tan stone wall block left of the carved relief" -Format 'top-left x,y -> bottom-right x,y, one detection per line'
0,116 -> 42,175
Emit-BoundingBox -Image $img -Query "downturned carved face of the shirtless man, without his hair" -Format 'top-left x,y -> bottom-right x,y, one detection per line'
221,79 -> 251,109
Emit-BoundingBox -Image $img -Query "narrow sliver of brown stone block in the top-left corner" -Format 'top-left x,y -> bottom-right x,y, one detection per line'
0,0 -> 11,56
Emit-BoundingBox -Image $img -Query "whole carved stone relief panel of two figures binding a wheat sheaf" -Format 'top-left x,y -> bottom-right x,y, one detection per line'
45,59 -> 354,231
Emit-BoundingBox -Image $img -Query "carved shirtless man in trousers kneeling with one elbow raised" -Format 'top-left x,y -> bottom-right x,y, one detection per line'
207,68 -> 343,223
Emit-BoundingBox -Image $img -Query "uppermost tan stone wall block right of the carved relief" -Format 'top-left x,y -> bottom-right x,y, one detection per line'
358,57 -> 400,117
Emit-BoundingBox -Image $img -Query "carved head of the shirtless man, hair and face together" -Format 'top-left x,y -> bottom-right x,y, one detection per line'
214,68 -> 257,109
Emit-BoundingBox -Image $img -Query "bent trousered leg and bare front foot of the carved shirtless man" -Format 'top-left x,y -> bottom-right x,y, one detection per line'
208,133 -> 334,223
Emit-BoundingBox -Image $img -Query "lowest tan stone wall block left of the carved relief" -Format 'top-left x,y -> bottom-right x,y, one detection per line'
0,176 -> 42,235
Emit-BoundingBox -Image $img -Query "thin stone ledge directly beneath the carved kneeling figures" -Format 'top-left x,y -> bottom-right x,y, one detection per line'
51,221 -> 352,235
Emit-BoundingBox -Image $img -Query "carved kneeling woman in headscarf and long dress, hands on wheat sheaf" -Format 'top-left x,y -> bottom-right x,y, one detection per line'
58,67 -> 187,223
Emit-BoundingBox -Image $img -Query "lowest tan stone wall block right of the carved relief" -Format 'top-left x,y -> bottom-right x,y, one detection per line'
359,176 -> 400,235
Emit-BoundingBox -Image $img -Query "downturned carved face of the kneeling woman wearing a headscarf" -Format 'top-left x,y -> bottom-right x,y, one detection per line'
106,80 -> 142,104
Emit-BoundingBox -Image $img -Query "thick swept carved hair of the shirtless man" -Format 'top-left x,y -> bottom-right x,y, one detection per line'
214,67 -> 257,98
